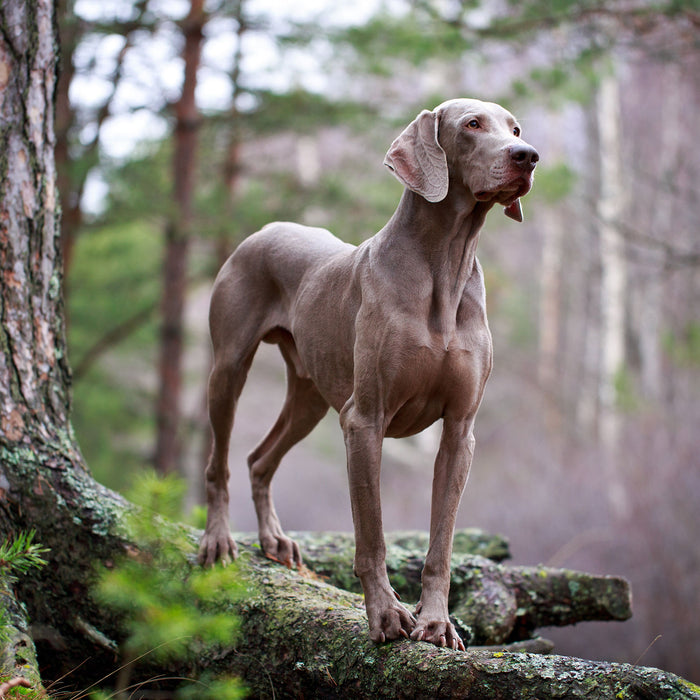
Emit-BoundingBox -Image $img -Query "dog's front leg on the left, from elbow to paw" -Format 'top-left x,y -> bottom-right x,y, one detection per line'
340,399 -> 416,642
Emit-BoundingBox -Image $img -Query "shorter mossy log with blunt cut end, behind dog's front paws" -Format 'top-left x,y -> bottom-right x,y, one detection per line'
239,529 -> 632,645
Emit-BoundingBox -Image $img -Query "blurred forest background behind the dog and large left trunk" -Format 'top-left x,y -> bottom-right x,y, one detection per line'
56,0 -> 700,682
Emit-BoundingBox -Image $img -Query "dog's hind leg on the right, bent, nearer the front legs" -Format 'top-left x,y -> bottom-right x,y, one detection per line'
248,330 -> 328,568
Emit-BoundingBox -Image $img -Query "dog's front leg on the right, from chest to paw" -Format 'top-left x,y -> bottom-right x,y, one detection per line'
411,418 -> 474,650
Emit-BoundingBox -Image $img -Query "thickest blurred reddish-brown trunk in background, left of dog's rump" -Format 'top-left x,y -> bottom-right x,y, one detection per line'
155,0 -> 205,474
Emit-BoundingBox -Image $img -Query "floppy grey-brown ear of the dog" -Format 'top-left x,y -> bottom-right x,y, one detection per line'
384,109 -> 449,202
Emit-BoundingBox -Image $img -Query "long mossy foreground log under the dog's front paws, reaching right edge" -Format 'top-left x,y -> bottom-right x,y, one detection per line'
212,547 -> 700,700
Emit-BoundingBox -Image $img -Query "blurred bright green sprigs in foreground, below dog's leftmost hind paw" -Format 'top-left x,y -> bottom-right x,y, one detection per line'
96,472 -> 246,698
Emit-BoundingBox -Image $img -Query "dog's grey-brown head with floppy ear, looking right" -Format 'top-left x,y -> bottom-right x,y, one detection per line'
384,99 -> 539,221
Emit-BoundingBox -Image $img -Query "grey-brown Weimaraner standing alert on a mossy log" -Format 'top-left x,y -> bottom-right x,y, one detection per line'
199,99 -> 539,649
